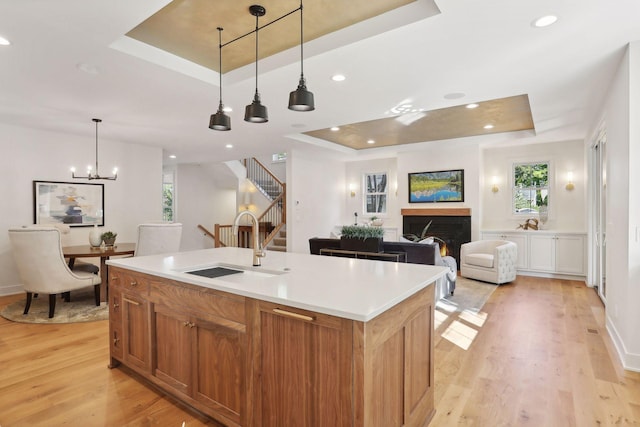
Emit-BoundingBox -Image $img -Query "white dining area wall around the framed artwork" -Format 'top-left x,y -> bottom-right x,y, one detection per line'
0,124 -> 162,295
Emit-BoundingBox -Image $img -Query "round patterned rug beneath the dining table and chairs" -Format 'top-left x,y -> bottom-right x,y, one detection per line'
0,289 -> 109,323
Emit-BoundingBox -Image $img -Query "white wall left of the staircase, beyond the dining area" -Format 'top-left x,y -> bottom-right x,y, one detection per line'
174,165 -> 236,251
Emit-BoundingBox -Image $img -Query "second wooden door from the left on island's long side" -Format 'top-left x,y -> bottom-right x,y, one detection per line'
152,304 -> 195,396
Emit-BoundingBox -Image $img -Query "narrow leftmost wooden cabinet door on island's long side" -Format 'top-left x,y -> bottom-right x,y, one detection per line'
122,292 -> 151,373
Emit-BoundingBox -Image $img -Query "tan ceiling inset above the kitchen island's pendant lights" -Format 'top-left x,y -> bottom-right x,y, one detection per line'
127,0 -> 415,73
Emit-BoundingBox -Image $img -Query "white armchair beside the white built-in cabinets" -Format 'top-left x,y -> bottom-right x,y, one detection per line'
460,240 -> 518,285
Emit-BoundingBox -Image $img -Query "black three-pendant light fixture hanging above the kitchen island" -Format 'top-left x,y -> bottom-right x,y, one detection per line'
209,0 -> 315,131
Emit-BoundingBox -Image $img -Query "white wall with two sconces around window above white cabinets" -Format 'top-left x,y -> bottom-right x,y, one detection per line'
479,141 -> 587,231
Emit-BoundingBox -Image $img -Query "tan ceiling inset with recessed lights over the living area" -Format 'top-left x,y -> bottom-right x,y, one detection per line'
304,95 -> 535,150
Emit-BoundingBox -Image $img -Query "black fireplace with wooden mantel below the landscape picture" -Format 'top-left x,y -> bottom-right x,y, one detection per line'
402,208 -> 471,268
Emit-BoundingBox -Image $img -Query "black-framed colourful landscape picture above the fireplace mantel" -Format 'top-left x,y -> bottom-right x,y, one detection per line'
409,169 -> 464,203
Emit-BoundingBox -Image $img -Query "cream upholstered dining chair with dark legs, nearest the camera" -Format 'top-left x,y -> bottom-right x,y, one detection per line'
9,227 -> 101,318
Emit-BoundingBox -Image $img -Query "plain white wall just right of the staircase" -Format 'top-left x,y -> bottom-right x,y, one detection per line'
287,149 -> 346,253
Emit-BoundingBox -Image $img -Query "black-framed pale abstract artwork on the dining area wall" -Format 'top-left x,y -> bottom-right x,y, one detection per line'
33,181 -> 104,227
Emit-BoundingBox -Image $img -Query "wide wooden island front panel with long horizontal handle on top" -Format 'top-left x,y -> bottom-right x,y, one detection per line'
254,302 -> 353,427
